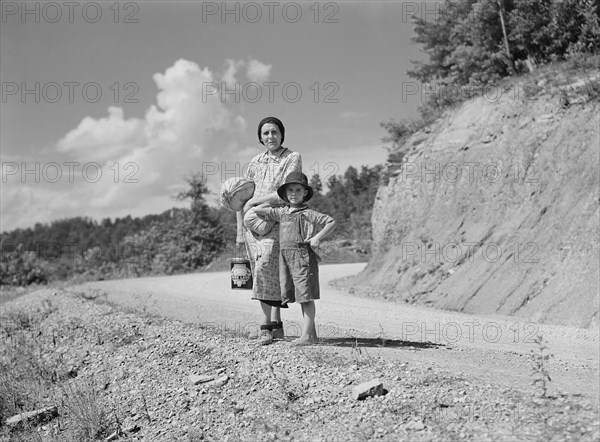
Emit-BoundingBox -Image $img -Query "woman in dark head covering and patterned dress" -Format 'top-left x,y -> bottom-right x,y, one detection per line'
236,117 -> 302,345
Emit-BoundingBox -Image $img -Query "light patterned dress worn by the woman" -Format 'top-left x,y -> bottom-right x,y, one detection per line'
244,147 -> 302,301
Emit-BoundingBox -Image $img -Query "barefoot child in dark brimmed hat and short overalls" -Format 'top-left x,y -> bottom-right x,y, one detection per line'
255,172 -> 335,345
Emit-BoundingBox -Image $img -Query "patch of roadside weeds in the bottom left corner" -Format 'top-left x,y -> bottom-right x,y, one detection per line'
0,292 -> 115,440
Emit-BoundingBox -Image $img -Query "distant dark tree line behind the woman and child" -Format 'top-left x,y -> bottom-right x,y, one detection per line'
0,166 -> 381,286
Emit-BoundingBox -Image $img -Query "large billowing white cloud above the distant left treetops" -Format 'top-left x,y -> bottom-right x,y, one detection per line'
2,59 -> 270,230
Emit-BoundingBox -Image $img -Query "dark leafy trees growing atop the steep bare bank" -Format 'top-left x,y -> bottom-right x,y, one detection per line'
380,0 -> 600,163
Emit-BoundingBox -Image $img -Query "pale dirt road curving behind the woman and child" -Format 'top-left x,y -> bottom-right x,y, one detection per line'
70,264 -> 600,400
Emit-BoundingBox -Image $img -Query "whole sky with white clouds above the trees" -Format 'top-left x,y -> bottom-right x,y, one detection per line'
0,1 -> 435,231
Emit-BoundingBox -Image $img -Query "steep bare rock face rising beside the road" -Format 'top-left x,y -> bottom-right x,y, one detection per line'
355,78 -> 600,327
